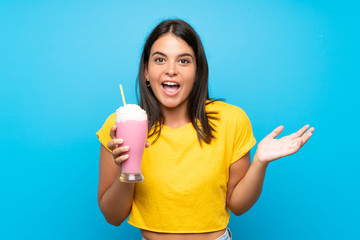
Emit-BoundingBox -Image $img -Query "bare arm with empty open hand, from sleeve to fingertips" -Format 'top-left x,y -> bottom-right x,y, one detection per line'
226,125 -> 314,216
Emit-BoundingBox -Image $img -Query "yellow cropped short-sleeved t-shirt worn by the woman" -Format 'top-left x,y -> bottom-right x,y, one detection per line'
97,101 -> 256,233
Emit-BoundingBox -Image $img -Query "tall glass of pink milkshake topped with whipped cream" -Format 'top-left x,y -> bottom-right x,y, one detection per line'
115,104 -> 148,183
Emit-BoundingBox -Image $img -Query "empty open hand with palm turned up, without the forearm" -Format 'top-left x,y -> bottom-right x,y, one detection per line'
256,125 -> 315,162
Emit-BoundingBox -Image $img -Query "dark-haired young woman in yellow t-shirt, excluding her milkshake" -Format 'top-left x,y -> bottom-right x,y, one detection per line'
97,20 -> 314,240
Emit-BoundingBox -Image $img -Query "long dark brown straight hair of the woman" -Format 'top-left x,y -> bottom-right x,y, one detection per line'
136,19 -> 216,144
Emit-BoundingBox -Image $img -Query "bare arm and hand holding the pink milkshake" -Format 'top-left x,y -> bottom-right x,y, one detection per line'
98,126 -> 135,226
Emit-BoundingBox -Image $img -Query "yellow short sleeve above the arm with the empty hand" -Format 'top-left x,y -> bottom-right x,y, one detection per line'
231,109 -> 256,164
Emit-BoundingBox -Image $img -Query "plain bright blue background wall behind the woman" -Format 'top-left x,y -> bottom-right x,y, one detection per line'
0,0 -> 360,239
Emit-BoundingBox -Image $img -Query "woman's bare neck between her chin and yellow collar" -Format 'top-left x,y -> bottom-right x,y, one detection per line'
161,104 -> 190,128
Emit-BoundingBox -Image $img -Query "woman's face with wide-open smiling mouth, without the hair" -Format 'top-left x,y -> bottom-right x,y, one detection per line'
145,33 -> 196,109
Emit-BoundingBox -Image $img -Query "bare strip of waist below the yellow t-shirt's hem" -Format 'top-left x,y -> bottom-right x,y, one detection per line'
141,228 -> 230,240
